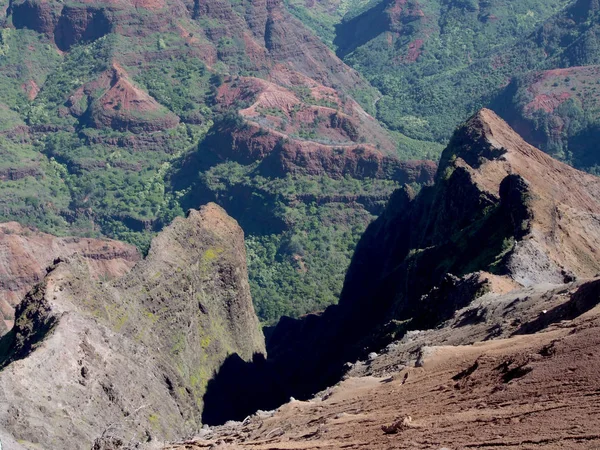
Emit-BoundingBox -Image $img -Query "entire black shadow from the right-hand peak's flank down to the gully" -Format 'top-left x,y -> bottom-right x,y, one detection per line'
203,170 -> 527,424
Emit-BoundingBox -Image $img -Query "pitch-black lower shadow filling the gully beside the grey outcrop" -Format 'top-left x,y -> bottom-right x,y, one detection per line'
202,278 -> 404,425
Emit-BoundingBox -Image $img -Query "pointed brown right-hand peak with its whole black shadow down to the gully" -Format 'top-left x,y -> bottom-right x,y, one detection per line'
198,110 -> 600,423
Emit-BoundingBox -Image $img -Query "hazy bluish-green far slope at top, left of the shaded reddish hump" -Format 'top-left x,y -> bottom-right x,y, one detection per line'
335,0 -> 576,140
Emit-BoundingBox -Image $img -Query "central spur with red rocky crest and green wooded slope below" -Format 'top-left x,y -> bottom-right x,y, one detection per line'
171,74 -> 436,322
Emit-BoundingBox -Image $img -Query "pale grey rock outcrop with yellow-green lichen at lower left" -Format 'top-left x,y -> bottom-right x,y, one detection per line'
0,204 -> 264,450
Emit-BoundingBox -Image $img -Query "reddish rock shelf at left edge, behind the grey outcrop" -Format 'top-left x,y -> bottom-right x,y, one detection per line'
0,222 -> 140,335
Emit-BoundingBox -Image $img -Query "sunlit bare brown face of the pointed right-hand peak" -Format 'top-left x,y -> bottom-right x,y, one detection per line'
468,109 -> 600,284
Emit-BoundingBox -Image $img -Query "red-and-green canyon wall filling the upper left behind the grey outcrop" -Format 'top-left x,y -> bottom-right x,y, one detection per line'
0,0 -> 441,320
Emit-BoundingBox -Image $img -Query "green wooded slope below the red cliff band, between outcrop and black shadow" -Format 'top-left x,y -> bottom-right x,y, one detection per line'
180,162 -> 399,323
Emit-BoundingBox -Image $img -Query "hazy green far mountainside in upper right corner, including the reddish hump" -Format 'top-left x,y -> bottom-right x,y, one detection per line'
314,0 -> 600,170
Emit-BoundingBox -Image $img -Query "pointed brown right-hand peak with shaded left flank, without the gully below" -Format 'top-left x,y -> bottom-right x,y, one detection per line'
340,110 -> 600,334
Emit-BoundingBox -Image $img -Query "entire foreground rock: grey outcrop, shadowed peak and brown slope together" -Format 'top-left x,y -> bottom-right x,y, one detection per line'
0,109 -> 600,449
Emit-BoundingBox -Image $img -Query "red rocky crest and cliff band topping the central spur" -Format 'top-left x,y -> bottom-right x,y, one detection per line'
196,75 -> 437,184
